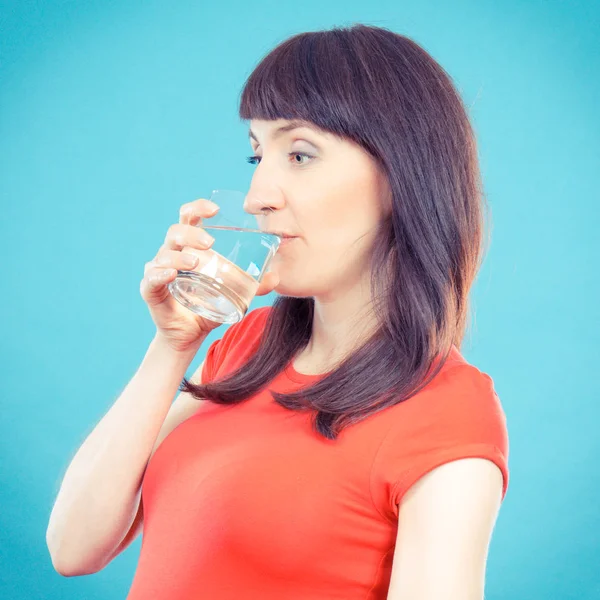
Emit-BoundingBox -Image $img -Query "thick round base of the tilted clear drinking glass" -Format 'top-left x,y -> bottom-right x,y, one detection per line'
168,271 -> 248,324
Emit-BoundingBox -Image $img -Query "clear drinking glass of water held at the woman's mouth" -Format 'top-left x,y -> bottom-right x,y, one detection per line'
168,190 -> 281,324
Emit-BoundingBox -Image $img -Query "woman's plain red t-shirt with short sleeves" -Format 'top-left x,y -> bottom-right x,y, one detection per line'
127,307 -> 508,600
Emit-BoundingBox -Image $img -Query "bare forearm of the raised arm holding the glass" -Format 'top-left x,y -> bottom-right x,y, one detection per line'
47,337 -> 203,567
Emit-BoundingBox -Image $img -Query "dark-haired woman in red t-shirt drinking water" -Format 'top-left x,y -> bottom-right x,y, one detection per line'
49,25 -> 508,600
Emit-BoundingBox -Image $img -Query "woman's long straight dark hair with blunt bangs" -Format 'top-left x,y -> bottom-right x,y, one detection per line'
180,24 -> 486,439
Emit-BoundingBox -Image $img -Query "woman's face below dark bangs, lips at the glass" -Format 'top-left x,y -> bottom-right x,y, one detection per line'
244,119 -> 390,300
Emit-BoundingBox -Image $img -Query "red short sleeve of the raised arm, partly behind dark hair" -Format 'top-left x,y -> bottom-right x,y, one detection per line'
202,306 -> 270,383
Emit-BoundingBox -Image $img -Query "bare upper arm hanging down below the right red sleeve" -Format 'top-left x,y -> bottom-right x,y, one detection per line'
388,458 -> 503,600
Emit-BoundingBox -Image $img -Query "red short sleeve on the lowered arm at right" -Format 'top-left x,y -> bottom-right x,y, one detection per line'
371,363 -> 509,520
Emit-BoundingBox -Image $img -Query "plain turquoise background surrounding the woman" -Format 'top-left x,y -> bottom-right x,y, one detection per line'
0,0 -> 600,600
